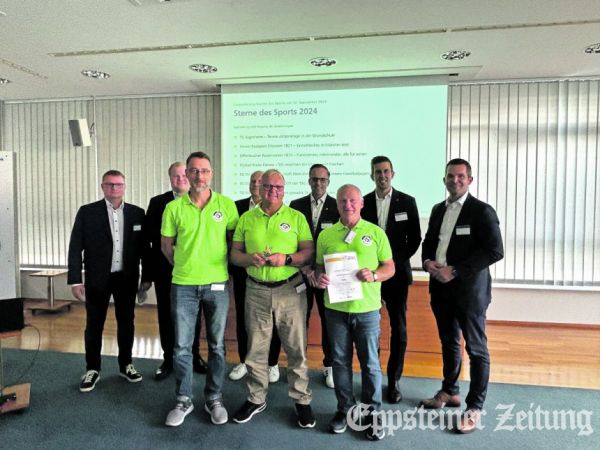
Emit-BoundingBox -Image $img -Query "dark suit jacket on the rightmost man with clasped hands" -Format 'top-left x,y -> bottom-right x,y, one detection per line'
421,194 -> 504,308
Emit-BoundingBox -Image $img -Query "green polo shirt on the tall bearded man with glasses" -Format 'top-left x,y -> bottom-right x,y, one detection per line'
160,191 -> 239,285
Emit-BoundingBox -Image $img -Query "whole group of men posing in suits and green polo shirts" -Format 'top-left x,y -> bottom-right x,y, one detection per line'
68,152 -> 503,440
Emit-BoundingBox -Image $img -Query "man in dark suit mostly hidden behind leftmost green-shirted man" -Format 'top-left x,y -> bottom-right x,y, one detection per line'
146,161 -> 207,380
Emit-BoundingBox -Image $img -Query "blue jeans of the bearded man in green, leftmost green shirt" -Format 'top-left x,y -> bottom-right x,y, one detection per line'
171,282 -> 229,401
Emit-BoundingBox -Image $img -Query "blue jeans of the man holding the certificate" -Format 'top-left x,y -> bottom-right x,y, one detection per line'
325,308 -> 381,414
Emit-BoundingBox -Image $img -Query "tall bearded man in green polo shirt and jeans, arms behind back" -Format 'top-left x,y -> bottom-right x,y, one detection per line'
161,152 -> 238,426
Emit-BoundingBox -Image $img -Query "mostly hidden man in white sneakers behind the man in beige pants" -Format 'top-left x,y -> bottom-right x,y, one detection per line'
229,170 -> 281,383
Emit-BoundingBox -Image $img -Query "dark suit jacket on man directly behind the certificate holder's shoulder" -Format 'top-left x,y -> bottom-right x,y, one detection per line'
361,188 -> 421,285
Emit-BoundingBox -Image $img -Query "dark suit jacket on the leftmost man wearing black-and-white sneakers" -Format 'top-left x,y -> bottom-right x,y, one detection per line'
67,199 -> 147,289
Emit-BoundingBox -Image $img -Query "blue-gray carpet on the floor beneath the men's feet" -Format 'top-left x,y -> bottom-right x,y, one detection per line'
0,349 -> 600,450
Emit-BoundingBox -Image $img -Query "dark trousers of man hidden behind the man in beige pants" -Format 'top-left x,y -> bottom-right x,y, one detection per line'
229,266 -> 281,366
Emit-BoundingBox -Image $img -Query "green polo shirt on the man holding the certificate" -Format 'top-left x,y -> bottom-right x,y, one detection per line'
317,219 -> 392,313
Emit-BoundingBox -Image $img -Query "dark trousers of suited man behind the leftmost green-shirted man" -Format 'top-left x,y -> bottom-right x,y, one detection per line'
154,274 -> 202,366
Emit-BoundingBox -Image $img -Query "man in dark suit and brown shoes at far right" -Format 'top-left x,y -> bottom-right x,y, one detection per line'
421,159 -> 504,433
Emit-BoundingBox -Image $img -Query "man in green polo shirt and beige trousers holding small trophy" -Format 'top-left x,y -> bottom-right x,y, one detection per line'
231,169 -> 316,428
